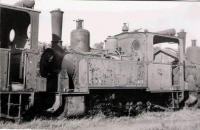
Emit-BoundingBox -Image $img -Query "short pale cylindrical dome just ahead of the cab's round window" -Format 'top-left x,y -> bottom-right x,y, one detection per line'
105,36 -> 117,53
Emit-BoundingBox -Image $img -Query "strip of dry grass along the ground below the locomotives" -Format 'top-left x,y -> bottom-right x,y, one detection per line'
0,109 -> 200,130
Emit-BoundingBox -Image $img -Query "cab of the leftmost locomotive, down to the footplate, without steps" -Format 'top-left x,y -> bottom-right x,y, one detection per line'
0,4 -> 39,91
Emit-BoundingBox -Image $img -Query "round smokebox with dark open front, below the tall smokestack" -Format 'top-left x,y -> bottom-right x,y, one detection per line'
40,48 -> 77,77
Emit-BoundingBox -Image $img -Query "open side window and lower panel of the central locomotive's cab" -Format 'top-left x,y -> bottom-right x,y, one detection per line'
148,35 -> 184,91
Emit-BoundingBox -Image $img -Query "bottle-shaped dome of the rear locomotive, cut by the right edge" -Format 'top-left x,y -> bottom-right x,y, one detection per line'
186,40 -> 200,63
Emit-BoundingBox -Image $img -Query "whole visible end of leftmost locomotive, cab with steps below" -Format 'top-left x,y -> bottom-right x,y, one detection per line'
0,1 -> 46,120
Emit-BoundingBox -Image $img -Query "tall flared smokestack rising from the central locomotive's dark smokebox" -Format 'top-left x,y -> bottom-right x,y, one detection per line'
51,9 -> 64,49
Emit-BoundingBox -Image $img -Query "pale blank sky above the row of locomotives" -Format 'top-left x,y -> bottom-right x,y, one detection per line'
0,0 -> 200,47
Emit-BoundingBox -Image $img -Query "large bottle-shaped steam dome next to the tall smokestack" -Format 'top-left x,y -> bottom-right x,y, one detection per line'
70,20 -> 90,52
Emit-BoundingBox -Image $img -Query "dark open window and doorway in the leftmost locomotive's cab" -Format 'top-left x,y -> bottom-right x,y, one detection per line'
1,8 -> 30,88
